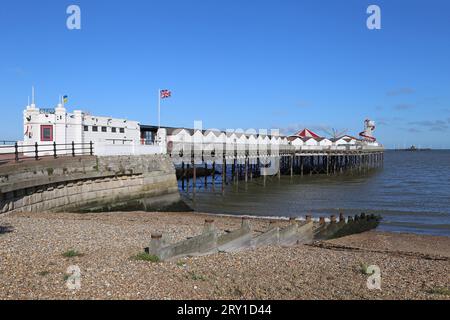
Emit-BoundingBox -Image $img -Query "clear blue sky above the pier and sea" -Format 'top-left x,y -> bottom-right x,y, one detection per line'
0,0 -> 450,148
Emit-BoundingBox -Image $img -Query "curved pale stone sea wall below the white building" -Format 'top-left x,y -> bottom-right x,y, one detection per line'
0,155 -> 180,213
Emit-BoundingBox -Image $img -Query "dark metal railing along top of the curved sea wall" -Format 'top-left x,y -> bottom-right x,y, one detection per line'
0,141 -> 94,164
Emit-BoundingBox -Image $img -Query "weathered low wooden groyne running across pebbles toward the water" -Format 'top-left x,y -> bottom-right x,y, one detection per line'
145,213 -> 381,261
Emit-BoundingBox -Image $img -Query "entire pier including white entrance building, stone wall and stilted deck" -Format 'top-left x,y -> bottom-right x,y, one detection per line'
0,99 -> 384,213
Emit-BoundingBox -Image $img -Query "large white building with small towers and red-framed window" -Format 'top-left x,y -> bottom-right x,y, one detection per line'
23,103 -> 164,156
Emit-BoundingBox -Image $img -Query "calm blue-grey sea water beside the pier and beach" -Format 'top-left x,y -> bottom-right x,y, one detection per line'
182,151 -> 450,236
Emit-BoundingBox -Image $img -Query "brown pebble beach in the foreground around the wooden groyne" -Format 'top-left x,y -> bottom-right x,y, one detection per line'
0,212 -> 450,300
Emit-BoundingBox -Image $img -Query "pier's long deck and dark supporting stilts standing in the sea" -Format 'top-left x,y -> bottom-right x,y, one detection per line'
168,143 -> 384,193
